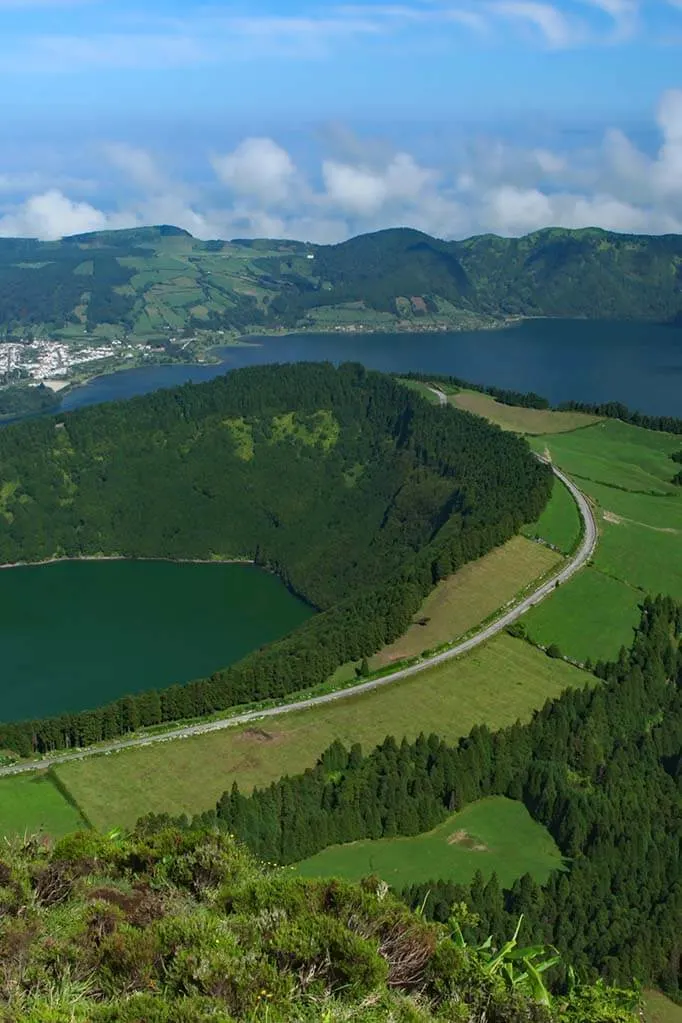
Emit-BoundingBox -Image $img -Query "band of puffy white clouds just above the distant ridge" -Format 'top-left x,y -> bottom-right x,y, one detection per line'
0,90 -> 682,242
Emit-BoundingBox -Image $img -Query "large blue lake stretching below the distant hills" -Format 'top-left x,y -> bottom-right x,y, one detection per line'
61,319 -> 682,416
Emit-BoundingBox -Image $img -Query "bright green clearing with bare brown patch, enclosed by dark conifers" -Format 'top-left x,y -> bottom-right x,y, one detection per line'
295,797 -> 562,888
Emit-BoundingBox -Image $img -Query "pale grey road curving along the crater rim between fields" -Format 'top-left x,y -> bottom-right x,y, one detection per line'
0,388 -> 597,776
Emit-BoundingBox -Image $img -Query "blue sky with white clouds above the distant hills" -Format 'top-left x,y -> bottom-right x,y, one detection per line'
0,0 -> 682,240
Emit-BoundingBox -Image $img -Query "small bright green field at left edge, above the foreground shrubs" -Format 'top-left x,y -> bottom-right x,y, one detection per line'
0,773 -> 86,837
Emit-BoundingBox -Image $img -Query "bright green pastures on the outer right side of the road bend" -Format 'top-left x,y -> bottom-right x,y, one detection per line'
519,419 -> 682,660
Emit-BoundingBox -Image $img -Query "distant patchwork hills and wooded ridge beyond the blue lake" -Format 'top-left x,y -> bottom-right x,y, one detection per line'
0,227 -> 682,338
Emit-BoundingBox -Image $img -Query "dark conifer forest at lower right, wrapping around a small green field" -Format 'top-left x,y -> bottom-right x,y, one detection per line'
161,597 -> 682,996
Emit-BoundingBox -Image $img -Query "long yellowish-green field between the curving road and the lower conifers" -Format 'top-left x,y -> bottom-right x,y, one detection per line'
57,634 -> 590,828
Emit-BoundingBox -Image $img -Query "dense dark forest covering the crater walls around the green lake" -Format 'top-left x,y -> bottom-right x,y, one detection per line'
0,363 -> 552,755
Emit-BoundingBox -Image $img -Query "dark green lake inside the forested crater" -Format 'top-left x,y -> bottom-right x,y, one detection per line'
0,562 -> 312,721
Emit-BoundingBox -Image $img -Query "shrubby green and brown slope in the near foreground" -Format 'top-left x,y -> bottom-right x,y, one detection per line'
0,830 -> 635,1023
